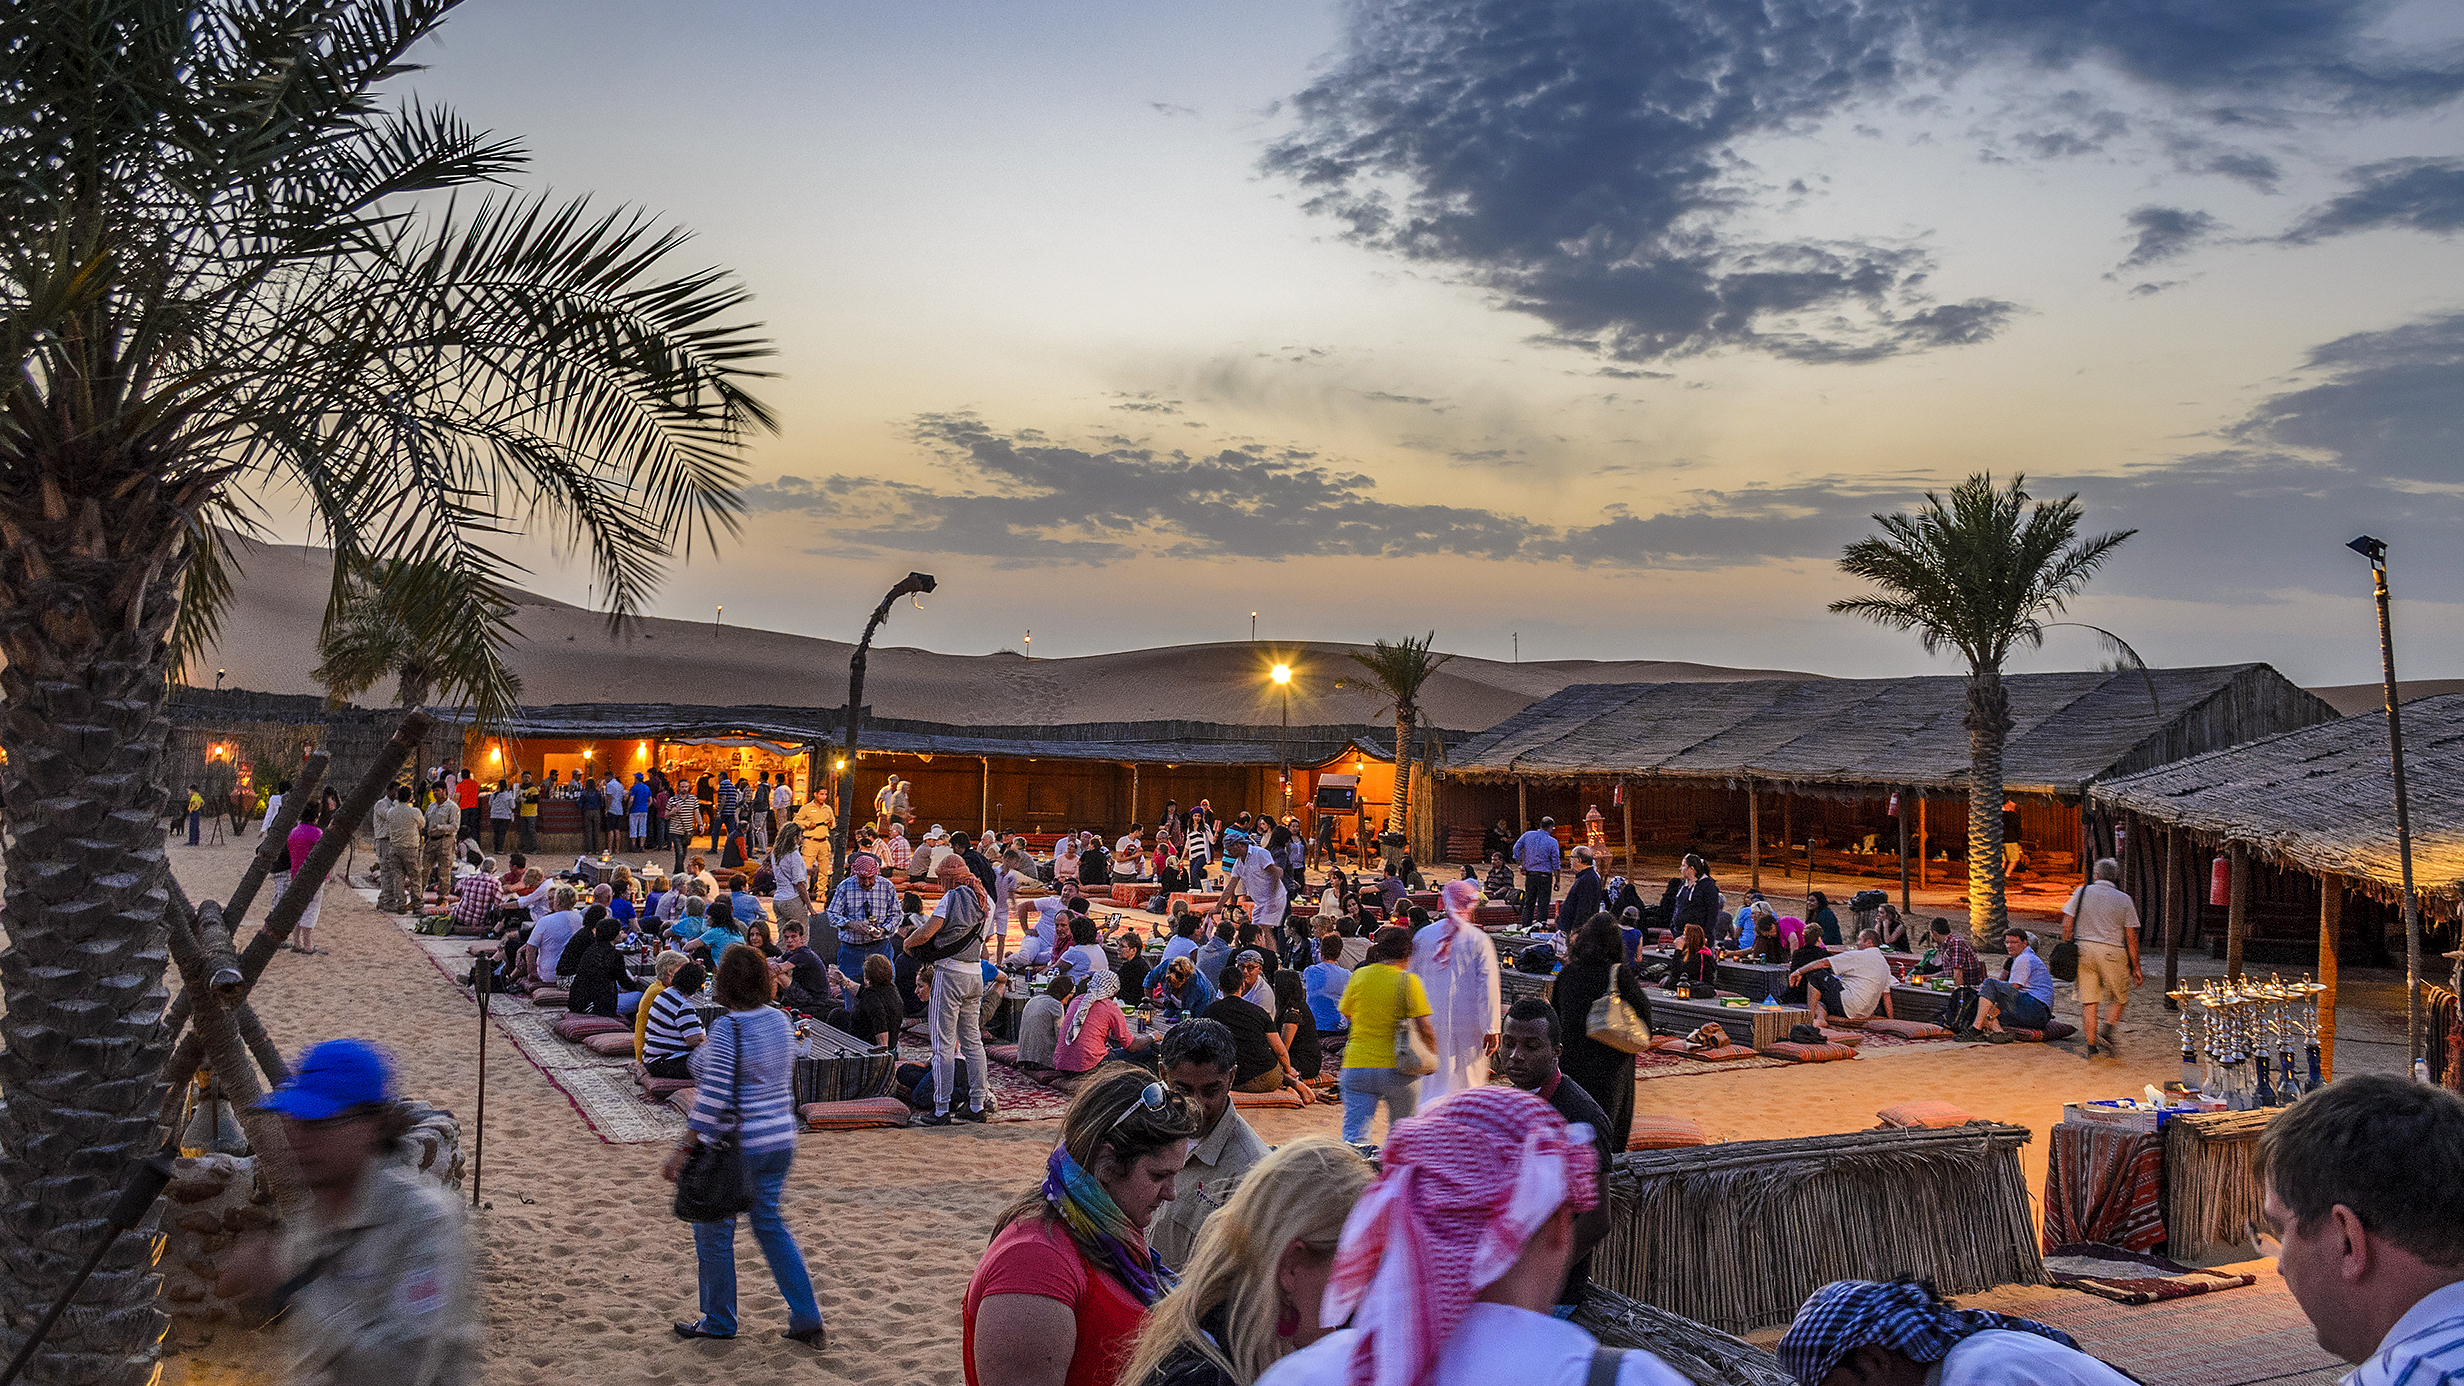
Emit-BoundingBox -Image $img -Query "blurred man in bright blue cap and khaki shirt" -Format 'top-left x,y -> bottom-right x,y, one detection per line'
214,1038 -> 478,1386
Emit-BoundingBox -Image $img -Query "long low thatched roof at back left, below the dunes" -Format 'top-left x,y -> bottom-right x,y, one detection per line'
172,688 -> 1429,765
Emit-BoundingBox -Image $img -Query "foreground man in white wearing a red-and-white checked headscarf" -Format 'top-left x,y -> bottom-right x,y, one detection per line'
1257,1088 -> 1685,1386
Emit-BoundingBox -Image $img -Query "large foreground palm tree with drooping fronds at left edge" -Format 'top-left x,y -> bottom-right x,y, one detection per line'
0,0 -> 769,1386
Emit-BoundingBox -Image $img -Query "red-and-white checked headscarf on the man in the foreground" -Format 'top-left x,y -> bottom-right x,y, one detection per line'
1318,1088 -> 1599,1386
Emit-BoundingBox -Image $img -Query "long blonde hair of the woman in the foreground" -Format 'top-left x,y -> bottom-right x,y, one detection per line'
1121,1134 -> 1370,1381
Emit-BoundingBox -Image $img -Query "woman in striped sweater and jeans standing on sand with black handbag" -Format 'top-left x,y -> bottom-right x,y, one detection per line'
663,945 -> 823,1349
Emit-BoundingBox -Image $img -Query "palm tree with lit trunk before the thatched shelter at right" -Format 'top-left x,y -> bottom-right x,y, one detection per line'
1831,471 -> 2139,947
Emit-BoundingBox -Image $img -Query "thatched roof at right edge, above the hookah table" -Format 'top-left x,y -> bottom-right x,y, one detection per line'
2092,693 -> 2464,900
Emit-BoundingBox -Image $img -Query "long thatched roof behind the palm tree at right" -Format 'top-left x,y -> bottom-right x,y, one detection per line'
1446,663 -> 2336,797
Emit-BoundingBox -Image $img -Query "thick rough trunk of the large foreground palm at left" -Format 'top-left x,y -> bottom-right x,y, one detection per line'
0,480 -> 195,1386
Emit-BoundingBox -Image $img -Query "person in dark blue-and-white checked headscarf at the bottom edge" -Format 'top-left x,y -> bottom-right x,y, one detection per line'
1779,1280 -> 2131,1386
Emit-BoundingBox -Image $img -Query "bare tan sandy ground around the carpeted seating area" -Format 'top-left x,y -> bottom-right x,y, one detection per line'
129,823 -> 2400,1386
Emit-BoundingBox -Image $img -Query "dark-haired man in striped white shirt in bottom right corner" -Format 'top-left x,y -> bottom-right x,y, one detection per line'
2257,1073 -> 2464,1386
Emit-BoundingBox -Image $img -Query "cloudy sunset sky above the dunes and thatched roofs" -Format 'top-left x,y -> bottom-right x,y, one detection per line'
337,0 -> 2464,683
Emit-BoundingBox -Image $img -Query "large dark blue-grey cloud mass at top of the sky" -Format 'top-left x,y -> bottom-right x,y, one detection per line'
1264,0 -> 2464,363
